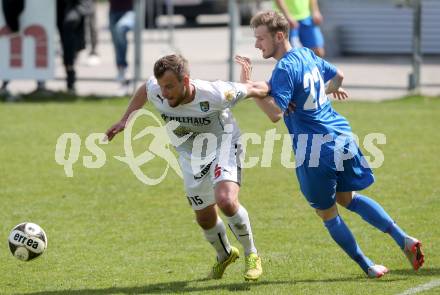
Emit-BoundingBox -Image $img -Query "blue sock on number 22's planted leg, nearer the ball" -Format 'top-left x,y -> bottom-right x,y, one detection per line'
324,215 -> 374,273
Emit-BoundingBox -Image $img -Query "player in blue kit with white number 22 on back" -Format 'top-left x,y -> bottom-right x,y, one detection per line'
242,11 -> 424,278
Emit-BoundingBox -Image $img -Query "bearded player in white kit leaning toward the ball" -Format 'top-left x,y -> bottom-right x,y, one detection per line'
106,55 -> 273,280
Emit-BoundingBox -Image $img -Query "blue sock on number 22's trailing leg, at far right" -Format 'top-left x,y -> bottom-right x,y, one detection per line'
347,194 -> 407,249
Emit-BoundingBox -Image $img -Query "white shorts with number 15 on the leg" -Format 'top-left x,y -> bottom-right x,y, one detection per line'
179,142 -> 243,210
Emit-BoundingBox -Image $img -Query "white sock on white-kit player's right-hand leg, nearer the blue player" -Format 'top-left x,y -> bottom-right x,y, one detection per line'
228,205 -> 257,256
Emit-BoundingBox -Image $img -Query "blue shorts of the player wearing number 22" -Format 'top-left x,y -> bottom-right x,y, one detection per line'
296,146 -> 374,210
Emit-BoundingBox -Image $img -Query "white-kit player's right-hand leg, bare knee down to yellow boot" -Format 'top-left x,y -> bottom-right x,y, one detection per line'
215,181 -> 263,280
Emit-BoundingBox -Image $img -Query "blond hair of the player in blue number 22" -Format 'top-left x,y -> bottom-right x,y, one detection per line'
251,10 -> 289,38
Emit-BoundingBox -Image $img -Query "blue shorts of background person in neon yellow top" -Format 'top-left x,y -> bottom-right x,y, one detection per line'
289,16 -> 324,49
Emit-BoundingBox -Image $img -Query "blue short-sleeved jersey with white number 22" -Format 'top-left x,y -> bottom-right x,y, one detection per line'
269,47 -> 351,155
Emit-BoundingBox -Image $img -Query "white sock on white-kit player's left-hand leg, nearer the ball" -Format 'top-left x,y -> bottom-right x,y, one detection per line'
203,217 -> 231,261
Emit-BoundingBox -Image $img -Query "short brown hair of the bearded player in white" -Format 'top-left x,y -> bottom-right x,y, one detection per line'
154,54 -> 189,81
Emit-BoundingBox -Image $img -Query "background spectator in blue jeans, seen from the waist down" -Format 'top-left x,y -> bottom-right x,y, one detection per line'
109,0 -> 135,95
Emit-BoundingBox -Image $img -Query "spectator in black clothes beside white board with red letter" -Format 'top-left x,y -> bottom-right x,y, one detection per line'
57,0 -> 93,93
